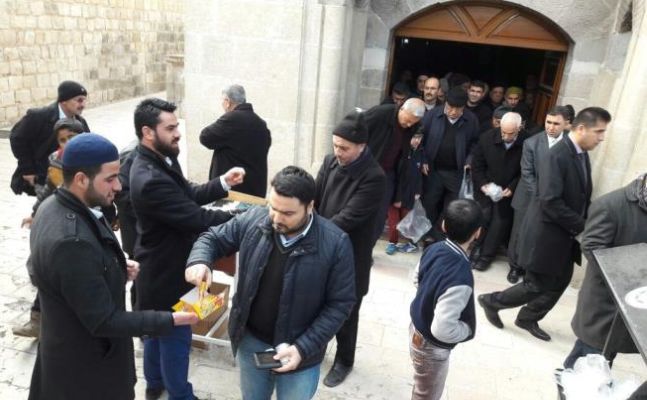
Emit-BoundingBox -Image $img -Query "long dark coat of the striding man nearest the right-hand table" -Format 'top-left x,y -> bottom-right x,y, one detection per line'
518,136 -> 592,276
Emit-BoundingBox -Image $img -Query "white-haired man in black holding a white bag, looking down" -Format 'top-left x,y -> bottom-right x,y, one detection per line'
472,112 -> 526,271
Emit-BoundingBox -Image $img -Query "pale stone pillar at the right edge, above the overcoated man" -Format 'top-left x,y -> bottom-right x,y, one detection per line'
593,0 -> 647,195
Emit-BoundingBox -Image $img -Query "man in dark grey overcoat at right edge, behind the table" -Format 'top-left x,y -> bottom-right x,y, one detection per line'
564,174 -> 647,368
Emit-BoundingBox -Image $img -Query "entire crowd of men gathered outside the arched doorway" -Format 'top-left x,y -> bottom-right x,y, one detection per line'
6,75 -> 647,400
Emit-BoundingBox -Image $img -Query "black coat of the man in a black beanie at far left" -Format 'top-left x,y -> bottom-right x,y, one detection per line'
9,103 -> 90,196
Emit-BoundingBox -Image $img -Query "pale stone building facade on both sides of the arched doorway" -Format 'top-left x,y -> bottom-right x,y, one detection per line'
185,0 -> 647,200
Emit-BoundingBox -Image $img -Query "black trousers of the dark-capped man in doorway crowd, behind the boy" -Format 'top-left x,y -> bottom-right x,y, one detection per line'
422,169 -> 463,239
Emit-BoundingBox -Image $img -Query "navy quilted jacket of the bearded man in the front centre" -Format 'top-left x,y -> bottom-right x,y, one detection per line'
187,207 -> 355,369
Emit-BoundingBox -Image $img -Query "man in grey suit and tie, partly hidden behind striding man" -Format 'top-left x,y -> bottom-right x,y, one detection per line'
508,106 -> 568,284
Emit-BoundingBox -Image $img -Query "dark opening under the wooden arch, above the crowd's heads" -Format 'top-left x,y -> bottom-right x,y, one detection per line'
388,37 -> 551,124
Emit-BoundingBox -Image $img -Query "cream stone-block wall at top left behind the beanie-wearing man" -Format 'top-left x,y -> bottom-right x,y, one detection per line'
0,0 -> 184,126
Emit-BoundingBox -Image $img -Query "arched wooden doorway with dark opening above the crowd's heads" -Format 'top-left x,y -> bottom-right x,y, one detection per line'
388,0 -> 570,124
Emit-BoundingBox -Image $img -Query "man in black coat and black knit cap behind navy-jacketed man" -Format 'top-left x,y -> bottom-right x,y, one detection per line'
315,112 -> 386,387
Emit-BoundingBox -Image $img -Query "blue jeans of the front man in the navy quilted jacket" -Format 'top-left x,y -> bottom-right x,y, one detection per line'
236,333 -> 321,400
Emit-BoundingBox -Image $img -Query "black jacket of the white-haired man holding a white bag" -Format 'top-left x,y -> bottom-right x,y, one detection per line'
472,128 -> 526,209
